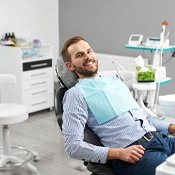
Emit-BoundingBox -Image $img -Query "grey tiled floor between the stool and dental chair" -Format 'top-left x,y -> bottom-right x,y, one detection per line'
0,110 -> 90,175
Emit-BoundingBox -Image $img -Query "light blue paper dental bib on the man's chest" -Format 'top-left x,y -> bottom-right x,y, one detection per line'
76,77 -> 139,125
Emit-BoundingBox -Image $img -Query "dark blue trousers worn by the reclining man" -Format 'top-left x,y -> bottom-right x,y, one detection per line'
111,131 -> 175,175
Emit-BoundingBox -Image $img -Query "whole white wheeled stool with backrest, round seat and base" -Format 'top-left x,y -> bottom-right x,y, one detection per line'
0,74 -> 38,173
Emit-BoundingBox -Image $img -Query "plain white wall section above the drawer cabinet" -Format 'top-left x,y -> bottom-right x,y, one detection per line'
0,0 -> 59,81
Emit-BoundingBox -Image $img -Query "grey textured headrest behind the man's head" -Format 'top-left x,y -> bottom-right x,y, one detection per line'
55,59 -> 78,89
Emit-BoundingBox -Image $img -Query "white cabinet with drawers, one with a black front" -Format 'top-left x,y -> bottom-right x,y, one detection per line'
0,45 -> 54,113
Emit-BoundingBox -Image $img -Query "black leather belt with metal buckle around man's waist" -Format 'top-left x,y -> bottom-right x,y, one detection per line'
129,131 -> 157,146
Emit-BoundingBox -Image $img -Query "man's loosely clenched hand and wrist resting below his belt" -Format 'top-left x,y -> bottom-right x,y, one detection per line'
108,145 -> 145,164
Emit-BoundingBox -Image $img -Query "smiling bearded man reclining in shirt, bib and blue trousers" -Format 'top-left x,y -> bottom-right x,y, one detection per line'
61,36 -> 175,175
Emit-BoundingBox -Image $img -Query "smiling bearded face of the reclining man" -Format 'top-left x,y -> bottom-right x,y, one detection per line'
66,40 -> 98,78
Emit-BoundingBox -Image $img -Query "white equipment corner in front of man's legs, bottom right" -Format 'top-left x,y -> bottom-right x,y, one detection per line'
156,154 -> 175,175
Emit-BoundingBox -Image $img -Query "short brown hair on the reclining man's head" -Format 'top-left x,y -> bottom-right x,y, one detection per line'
61,36 -> 87,62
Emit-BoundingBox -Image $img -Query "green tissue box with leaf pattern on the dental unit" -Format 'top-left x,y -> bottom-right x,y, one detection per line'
136,66 -> 155,82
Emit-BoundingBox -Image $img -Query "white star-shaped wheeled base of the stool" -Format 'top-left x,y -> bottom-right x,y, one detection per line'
0,147 -> 39,173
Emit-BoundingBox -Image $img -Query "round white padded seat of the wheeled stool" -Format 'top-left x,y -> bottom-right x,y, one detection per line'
0,103 -> 28,125
